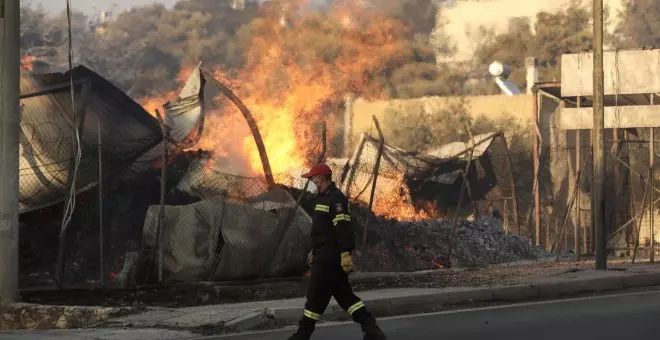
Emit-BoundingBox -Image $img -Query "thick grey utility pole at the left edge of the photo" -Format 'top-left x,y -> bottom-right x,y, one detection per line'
0,0 -> 21,305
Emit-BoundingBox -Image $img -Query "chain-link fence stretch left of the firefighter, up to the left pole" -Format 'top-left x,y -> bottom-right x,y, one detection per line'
20,122 -> 336,289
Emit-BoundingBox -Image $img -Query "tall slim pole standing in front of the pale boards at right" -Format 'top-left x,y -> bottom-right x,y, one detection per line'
591,0 -> 607,270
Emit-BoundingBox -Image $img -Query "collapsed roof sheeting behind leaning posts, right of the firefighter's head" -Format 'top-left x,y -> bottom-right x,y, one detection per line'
335,132 -> 517,224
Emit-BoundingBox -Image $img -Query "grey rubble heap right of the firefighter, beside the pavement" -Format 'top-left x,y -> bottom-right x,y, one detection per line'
353,207 -> 548,272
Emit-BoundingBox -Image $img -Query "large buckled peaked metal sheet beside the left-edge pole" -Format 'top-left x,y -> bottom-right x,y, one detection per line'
19,66 -> 161,213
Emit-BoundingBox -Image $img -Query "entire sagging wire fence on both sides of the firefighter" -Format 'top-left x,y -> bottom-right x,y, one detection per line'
20,115 -> 520,289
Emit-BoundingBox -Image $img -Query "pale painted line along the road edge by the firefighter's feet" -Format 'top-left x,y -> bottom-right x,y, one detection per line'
192,286 -> 660,340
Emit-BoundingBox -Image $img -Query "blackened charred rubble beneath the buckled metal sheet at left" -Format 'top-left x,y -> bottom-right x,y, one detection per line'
19,150 -> 207,287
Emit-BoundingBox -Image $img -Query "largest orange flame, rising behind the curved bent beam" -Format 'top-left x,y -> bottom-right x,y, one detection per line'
183,0 -> 404,175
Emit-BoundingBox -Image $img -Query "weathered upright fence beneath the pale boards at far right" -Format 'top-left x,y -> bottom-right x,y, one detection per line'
532,121 -> 660,258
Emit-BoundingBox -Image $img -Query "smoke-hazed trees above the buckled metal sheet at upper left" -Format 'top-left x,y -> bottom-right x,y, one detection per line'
21,0 -> 258,98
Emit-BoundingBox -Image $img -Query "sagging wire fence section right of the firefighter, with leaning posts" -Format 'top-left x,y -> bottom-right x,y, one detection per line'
336,133 -> 524,234
